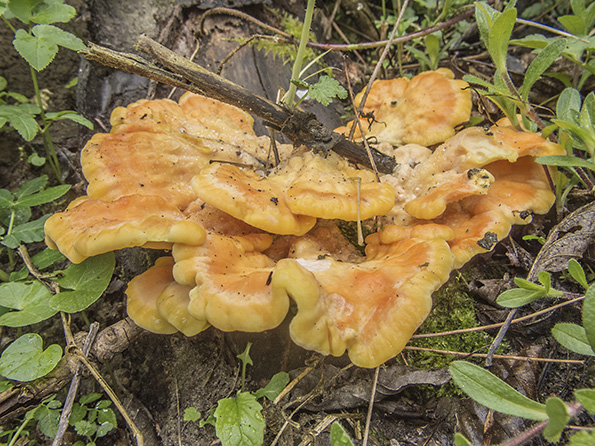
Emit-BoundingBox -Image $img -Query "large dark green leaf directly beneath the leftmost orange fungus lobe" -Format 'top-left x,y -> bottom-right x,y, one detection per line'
50,252 -> 116,312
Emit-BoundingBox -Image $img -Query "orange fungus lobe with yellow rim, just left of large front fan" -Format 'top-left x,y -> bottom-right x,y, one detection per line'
173,234 -> 289,332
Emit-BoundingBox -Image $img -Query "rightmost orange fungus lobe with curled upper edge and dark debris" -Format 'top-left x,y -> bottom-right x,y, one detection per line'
383,122 -> 564,268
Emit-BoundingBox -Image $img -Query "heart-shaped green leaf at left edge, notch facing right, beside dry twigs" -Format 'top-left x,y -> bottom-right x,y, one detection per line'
0,333 -> 62,382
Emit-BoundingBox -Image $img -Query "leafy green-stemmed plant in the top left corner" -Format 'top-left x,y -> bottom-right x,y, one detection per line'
0,0 -> 93,181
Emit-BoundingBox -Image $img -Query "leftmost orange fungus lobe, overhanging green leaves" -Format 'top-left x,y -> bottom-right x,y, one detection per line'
45,195 -> 206,263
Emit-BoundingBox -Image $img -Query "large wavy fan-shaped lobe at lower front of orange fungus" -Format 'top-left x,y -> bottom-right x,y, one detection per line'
272,231 -> 453,367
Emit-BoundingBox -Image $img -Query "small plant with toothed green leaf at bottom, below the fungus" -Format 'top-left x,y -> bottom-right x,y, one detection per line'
191,343 -> 289,446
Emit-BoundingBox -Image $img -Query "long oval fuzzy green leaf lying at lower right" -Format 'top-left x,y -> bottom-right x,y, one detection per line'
449,361 -> 547,421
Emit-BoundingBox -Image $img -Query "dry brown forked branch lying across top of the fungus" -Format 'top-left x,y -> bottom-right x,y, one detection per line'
81,36 -> 396,173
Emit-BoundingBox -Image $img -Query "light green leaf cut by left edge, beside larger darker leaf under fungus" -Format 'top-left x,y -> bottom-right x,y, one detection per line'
0,280 -> 57,327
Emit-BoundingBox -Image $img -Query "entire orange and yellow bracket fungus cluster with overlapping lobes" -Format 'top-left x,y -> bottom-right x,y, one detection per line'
45,69 -> 563,367
